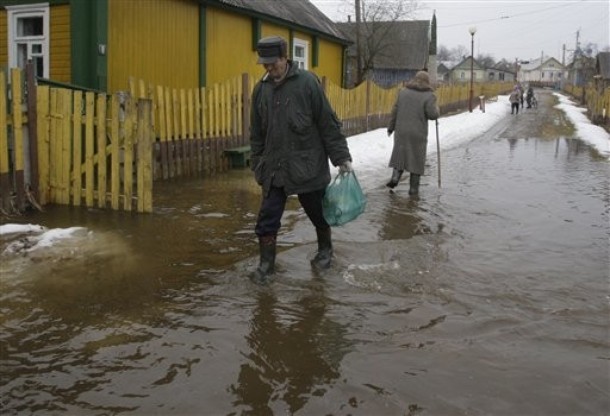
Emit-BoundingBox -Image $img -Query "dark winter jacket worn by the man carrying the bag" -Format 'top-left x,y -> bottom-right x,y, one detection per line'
250,61 -> 351,195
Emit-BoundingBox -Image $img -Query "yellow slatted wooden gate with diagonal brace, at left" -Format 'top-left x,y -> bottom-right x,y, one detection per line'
36,86 -> 154,212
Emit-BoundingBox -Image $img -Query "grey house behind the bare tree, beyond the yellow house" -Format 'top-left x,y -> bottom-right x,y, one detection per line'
337,20 -> 430,87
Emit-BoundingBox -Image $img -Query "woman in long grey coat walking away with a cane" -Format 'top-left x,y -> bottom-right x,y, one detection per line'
386,71 -> 440,195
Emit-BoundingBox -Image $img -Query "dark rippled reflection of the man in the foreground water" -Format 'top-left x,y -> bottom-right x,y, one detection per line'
231,286 -> 350,415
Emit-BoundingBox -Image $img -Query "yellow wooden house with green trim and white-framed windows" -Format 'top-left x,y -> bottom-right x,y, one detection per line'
0,0 -> 349,92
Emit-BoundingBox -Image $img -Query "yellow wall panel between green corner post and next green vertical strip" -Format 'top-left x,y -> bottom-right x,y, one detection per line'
108,0 -> 199,92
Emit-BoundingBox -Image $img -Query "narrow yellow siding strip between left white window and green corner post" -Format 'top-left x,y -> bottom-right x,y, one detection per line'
49,4 -> 71,82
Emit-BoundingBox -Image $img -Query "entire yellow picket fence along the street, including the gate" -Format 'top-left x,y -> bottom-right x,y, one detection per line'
0,65 -> 512,216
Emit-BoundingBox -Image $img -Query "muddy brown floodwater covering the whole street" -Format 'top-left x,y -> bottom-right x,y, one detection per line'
0,93 -> 610,416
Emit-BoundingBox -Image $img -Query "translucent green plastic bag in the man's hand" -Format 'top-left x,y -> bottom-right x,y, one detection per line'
322,171 -> 366,226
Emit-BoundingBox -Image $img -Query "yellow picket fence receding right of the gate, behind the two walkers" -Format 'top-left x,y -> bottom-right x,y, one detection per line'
128,74 -> 512,167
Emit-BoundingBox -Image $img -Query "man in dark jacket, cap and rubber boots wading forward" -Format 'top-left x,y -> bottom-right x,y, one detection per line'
250,36 -> 351,284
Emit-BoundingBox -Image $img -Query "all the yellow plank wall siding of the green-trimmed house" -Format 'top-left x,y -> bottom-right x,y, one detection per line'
0,0 -> 344,93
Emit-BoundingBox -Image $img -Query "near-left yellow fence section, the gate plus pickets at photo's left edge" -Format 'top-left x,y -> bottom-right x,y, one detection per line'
0,69 -> 154,213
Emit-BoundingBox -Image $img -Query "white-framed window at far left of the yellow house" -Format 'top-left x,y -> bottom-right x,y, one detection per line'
6,3 -> 49,78
